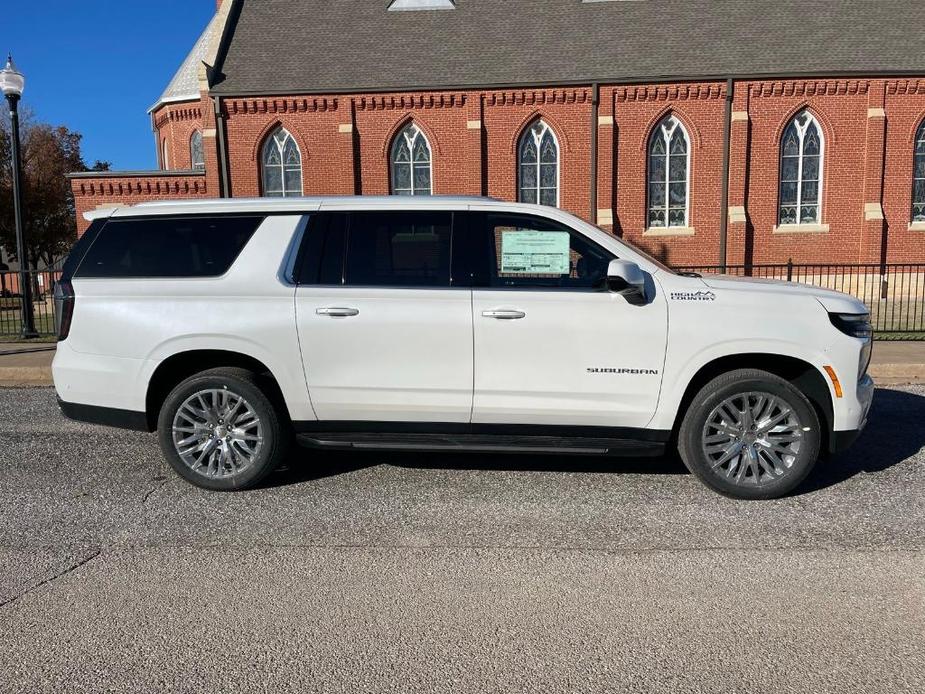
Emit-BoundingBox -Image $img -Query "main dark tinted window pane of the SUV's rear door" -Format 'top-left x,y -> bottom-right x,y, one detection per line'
345,212 -> 453,287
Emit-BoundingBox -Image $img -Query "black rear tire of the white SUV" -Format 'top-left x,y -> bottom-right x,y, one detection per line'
157,367 -> 291,491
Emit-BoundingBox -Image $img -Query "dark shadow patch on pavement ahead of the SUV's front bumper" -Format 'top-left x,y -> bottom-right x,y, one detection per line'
796,388 -> 925,494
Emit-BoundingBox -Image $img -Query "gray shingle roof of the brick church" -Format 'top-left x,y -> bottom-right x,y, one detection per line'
212,0 -> 925,95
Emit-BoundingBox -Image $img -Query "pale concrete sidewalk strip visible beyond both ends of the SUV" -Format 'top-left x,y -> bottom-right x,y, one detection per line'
0,341 -> 925,387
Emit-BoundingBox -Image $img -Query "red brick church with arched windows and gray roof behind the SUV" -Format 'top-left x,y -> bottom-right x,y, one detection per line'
71,0 -> 925,265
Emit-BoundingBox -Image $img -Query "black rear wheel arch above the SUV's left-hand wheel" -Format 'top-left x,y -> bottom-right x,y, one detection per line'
145,349 -> 289,431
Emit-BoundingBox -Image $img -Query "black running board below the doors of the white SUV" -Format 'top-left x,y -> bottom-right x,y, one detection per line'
297,432 -> 665,458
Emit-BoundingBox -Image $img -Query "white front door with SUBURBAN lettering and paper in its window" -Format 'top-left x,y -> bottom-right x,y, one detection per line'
470,213 -> 667,427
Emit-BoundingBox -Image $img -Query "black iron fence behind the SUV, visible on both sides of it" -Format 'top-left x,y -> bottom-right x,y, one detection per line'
0,262 -> 925,341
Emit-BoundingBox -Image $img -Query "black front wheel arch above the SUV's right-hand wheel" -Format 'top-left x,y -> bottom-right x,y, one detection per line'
672,352 -> 835,451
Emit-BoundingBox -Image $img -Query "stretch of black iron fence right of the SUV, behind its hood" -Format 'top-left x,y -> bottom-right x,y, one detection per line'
675,261 -> 925,338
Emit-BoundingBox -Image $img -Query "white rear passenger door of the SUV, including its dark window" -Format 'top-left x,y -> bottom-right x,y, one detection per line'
296,211 -> 472,423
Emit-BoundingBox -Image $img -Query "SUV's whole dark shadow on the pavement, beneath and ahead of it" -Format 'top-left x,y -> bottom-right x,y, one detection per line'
260,388 -> 925,495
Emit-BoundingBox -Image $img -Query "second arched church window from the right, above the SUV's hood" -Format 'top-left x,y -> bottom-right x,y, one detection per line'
778,111 -> 825,224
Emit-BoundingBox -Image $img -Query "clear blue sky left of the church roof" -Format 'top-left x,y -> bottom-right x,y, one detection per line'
0,0 -> 215,169
